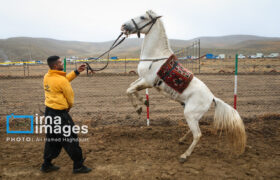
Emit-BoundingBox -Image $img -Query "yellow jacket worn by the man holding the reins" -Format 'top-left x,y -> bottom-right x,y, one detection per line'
44,70 -> 77,110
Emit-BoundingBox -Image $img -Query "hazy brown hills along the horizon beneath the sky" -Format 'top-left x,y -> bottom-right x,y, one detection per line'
0,35 -> 280,61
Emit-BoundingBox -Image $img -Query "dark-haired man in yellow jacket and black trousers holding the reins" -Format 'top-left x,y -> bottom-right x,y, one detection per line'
41,56 -> 91,173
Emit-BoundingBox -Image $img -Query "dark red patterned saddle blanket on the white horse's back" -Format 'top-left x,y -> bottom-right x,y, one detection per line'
157,54 -> 193,93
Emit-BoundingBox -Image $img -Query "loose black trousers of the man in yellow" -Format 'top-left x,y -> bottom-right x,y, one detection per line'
44,107 -> 84,169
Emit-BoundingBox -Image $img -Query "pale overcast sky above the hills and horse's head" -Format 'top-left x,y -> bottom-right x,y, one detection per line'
0,0 -> 280,42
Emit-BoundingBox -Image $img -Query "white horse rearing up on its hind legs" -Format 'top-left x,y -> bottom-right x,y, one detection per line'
121,10 -> 246,162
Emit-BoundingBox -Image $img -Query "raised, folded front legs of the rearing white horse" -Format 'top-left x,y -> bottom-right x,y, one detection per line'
126,78 -> 151,115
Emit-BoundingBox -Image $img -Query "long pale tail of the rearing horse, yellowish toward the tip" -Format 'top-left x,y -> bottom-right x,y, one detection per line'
214,97 -> 247,154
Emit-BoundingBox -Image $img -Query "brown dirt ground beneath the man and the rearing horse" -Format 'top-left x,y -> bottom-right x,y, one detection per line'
0,75 -> 280,179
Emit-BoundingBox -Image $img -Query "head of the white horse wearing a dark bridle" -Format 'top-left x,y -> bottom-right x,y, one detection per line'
121,10 -> 161,38
